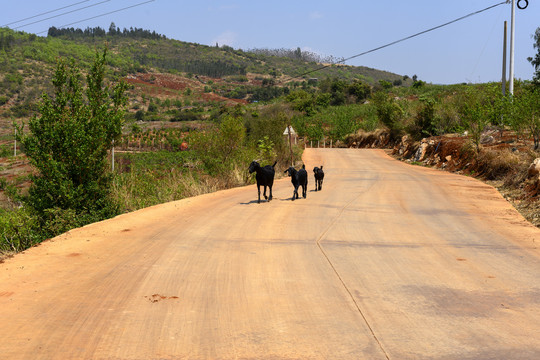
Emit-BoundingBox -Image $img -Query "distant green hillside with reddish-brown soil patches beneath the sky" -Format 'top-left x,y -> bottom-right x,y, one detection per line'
0,24 -> 410,126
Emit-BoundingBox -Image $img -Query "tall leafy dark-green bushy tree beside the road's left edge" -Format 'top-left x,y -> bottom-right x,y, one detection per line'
17,50 -> 126,225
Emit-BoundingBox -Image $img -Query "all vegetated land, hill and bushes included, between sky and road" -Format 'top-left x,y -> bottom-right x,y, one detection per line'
0,24 -> 540,253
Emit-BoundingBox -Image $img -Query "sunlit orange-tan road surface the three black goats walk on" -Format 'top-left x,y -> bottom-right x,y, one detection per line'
0,149 -> 540,359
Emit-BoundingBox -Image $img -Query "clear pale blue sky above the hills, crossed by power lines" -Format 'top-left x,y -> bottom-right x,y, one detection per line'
4,0 -> 540,84
